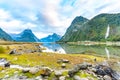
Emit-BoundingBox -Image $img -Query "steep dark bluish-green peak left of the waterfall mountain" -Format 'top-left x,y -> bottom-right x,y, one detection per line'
60,16 -> 88,41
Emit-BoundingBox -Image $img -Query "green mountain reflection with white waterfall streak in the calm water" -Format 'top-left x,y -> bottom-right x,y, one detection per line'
60,44 -> 120,59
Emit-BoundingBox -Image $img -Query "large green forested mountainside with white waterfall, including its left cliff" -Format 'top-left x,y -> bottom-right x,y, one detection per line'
61,13 -> 120,42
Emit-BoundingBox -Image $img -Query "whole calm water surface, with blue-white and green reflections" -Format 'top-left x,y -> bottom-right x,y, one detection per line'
43,43 -> 120,72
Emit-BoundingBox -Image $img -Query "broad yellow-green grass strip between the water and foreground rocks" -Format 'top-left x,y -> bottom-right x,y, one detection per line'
0,53 -> 104,69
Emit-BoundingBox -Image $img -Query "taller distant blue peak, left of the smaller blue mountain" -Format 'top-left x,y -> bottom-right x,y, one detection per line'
10,29 -> 39,42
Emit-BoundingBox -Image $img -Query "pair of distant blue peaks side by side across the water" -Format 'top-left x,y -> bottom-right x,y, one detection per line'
10,29 -> 61,42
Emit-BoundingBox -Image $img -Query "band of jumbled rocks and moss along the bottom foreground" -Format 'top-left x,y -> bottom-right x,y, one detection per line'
0,58 -> 120,80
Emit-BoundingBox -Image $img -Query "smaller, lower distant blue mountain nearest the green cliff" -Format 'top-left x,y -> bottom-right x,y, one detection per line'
40,33 -> 61,42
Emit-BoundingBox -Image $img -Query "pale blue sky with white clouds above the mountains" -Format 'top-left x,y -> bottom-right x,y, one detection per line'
0,0 -> 120,38
